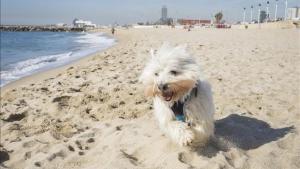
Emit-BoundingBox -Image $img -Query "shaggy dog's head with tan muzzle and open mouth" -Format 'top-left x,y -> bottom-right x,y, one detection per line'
140,44 -> 200,102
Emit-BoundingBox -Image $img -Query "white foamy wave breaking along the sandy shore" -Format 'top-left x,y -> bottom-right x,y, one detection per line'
0,33 -> 115,86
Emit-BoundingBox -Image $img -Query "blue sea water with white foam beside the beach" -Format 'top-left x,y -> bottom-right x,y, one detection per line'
0,32 -> 116,86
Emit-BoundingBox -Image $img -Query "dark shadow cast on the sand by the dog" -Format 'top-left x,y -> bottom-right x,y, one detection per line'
198,114 -> 294,157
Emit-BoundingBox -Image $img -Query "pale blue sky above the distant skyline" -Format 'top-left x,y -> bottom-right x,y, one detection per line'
1,0 -> 300,24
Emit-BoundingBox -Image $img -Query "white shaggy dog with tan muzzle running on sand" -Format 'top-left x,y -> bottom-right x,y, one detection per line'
140,43 -> 214,146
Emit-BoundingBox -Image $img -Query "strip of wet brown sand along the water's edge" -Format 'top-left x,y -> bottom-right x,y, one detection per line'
0,29 -> 115,95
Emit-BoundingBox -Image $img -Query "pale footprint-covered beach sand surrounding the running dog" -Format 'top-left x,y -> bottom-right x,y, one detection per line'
0,29 -> 300,169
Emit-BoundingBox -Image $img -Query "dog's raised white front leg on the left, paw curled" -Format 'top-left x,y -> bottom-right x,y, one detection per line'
153,98 -> 194,146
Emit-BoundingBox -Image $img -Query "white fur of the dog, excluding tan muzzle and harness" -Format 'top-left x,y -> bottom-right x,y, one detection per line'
140,43 -> 215,146
